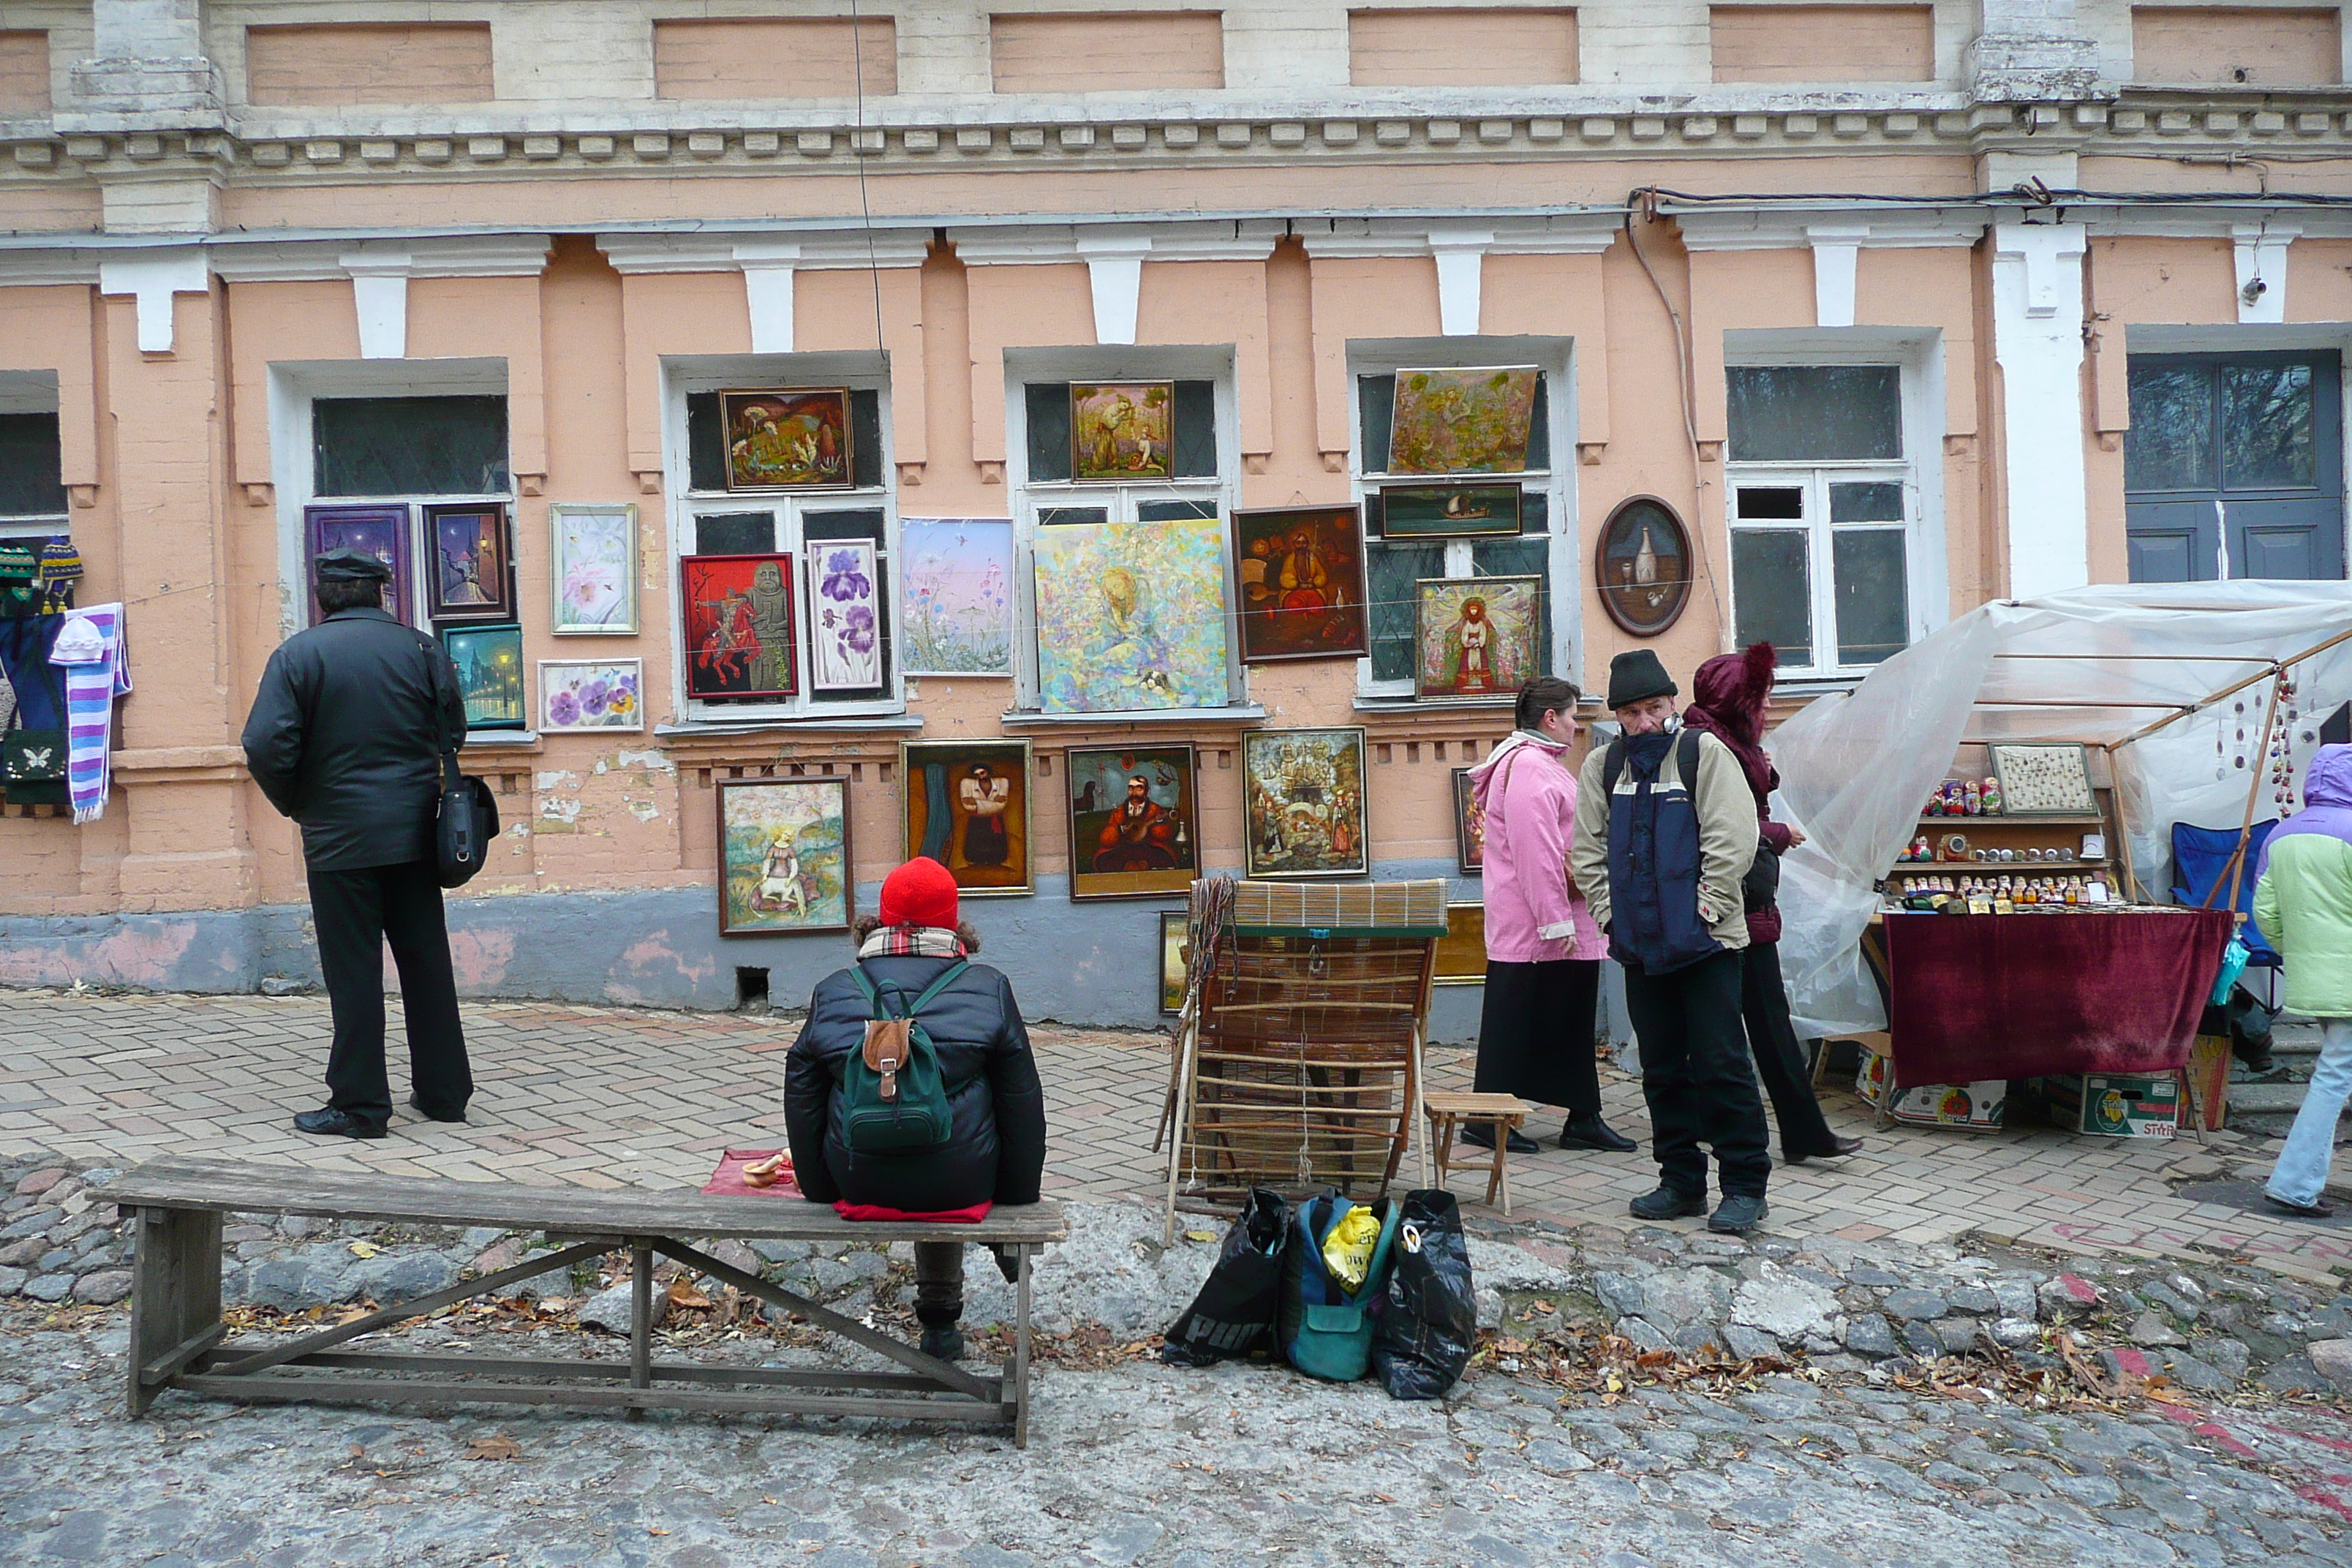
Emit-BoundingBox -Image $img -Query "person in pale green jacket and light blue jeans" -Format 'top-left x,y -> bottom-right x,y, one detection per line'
2253,745 -> 2352,1220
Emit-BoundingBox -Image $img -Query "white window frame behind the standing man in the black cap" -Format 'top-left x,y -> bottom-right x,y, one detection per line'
271,360 -> 517,639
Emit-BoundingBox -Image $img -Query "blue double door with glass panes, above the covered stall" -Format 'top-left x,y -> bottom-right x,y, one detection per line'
2124,350 -> 2345,583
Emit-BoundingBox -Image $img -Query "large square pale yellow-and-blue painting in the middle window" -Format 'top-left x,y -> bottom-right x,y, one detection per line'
1037,517 -> 1226,712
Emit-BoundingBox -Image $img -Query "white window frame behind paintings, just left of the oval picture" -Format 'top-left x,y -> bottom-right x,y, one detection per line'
1348,336 -> 1583,708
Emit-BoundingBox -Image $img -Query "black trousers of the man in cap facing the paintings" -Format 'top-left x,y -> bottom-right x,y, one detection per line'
308,860 -> 472,1126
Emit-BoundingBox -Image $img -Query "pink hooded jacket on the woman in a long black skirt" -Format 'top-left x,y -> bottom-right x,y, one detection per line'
1470,731 -> 1609,964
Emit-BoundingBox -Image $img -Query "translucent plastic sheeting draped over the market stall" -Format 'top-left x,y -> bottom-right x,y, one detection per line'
1766,583 -> 2352,1037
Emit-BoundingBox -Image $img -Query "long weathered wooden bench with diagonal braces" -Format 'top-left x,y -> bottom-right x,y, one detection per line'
106,1159 -> 1068,1446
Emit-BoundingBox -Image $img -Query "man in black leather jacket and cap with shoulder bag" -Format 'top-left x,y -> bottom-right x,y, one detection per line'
244,550 -> 472,1138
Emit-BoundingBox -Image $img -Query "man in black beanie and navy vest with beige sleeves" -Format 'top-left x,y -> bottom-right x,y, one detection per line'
1569,649 -> 1771,1235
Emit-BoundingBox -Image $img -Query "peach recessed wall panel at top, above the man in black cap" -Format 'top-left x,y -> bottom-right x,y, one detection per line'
244,21 -> 497,108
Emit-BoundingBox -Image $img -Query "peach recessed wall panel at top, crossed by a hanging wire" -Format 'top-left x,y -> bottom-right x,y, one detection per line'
654,17 -> 899,99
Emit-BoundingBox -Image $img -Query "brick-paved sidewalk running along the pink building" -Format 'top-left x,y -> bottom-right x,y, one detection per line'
0,992 -> 2352,1274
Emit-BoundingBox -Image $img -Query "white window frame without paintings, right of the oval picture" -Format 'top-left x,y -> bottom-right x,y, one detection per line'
1724,327 -> 1950,682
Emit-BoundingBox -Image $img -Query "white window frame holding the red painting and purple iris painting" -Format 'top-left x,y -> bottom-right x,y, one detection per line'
661,353 -> 905,726
